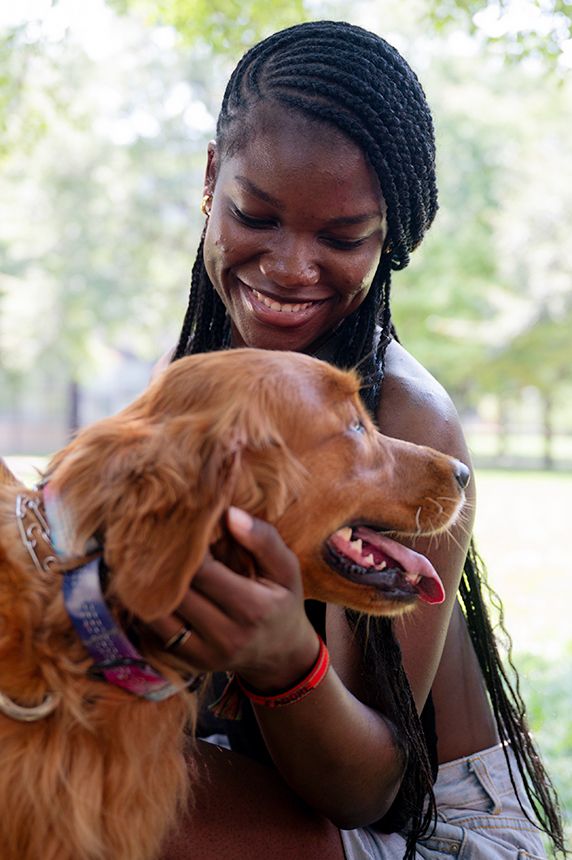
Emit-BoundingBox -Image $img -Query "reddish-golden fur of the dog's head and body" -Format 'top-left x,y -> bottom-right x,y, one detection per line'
0,349 -> 462,860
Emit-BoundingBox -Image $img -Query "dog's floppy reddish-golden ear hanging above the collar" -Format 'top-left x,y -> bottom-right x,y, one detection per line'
45,417 -> 237,621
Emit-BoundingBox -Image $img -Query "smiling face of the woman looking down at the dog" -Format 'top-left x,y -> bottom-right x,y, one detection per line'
204,105 -> 387,350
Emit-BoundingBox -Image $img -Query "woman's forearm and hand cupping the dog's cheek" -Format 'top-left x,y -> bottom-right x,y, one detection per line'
153,510 -> 404,827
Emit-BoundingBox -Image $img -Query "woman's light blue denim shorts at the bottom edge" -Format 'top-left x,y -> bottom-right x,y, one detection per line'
340,744 -> 546,860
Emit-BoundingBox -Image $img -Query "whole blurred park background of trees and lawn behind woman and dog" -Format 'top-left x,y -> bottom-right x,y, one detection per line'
0,0 -> 572,848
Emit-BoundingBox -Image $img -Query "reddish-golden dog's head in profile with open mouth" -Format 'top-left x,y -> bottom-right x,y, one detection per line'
48,349 -> 470,620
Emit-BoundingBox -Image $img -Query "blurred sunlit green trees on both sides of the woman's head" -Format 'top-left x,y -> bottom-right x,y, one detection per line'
0,0 -> 572,454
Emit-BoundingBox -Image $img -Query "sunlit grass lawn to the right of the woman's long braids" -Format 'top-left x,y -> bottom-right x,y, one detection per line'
475,471 -> 572,847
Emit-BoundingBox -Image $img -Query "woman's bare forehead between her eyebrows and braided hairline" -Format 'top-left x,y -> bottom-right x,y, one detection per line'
220,102 -> 383,208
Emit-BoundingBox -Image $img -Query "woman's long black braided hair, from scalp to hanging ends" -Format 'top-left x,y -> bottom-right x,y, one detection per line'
173,21 -> 563,860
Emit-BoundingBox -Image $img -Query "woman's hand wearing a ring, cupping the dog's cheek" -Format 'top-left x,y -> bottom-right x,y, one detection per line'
152,508 -> 319,692
